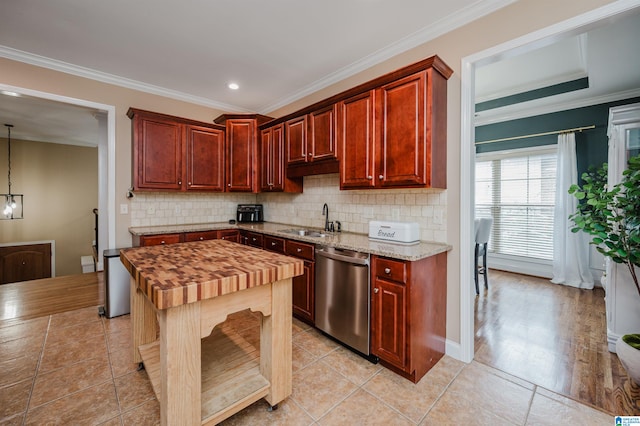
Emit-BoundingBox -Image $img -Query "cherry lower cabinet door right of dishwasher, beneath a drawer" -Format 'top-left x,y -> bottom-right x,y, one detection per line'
371,278 -> 407,369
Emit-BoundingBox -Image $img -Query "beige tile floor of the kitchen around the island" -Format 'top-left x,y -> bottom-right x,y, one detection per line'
0,308 -> 614,426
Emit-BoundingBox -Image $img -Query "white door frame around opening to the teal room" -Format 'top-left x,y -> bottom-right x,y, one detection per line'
459,0 -> 640,362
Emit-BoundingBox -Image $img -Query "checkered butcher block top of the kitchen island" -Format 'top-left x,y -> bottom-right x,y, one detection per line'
120,240 -> 303,309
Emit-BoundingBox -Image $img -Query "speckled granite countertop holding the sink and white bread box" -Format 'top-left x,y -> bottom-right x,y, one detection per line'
129,222 -> 452,261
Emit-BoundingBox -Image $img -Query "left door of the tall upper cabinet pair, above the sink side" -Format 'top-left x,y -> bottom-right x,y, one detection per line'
338,91 -> 376,189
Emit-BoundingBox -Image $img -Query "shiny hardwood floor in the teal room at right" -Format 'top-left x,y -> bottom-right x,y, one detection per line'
475,270 -> 640,415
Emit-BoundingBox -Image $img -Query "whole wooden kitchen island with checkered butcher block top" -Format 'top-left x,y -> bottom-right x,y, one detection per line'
120,240 -> 303,425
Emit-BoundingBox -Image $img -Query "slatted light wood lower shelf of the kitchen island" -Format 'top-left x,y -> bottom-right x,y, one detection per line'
139,326 -> 271,425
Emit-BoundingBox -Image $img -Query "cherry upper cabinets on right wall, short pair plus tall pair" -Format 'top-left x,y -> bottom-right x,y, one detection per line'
262,56 -> 453,189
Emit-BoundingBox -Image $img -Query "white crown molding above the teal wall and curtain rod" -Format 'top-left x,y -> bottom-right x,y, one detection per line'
474,89 -> 640,127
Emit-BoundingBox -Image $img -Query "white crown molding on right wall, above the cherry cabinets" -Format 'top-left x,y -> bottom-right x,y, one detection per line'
258,0 -> 517,115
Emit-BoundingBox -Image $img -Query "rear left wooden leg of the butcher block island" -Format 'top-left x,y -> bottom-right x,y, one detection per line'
129,277 -> 158,363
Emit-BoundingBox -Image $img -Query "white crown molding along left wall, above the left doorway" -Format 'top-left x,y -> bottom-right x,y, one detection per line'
0,45 -> 253,113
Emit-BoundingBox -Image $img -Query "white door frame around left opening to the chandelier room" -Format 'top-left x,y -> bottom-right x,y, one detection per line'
0,84 -> 116,271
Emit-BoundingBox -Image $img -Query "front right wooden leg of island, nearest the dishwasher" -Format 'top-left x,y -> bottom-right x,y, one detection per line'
260,278 -> 292,407
